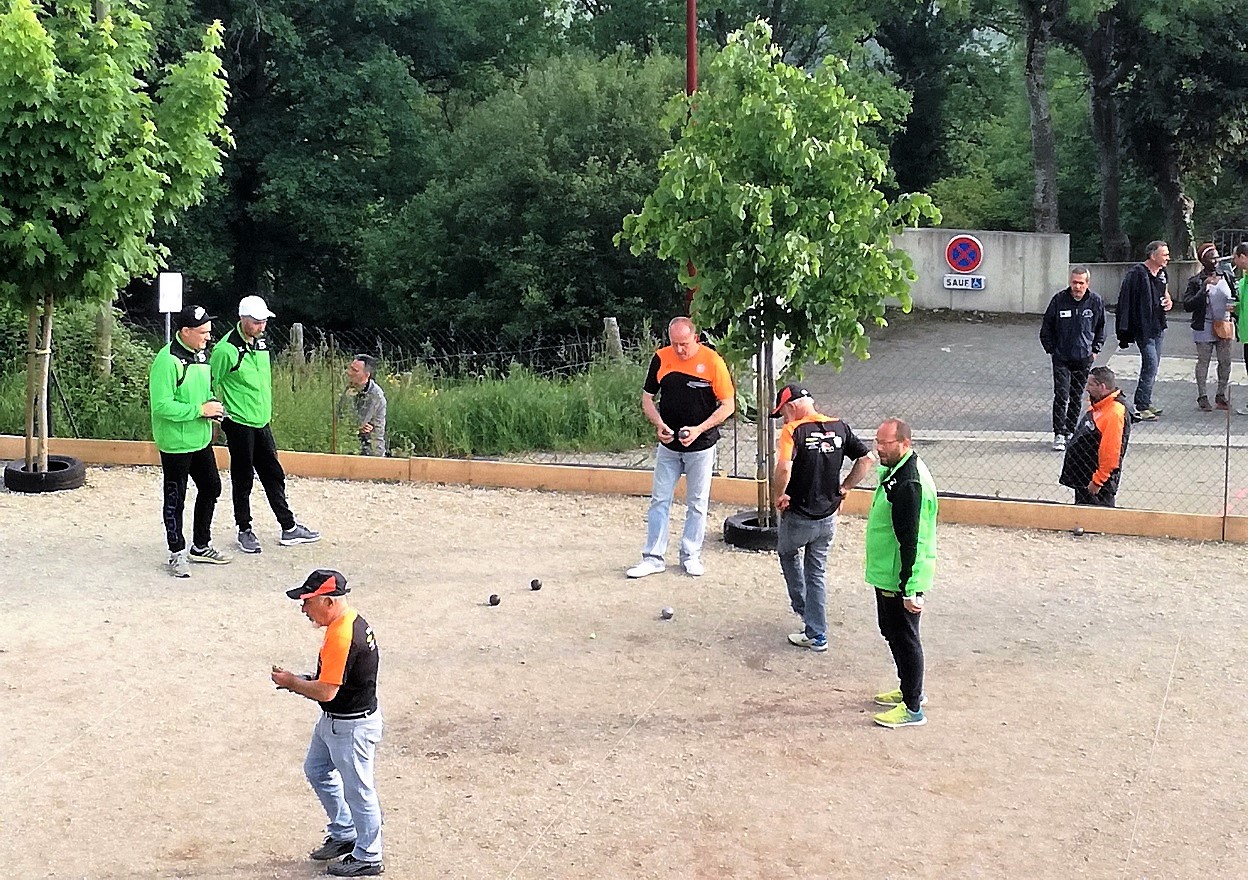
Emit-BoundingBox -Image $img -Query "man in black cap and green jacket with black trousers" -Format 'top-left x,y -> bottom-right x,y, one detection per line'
147,306 -> 230,578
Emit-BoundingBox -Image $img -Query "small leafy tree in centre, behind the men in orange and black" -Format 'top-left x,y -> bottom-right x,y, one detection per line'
617,21 -> 940,524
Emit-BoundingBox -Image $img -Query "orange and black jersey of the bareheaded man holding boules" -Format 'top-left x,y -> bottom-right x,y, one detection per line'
643,345 -> 736,452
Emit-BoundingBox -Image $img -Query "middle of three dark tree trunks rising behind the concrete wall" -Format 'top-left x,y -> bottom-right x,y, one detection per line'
1083,11 -> 1132,262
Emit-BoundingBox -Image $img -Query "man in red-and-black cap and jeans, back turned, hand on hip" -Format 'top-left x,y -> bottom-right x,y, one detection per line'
771,384 -> 871,652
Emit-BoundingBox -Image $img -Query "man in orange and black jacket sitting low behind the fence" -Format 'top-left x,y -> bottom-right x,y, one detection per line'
1058,367 -> 1131,507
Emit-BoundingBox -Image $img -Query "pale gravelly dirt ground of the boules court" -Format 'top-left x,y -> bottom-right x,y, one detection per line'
0,468 -> 1248,880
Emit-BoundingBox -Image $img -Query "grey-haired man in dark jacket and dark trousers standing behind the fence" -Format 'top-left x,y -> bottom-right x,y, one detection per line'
1040,266 -> 1104,452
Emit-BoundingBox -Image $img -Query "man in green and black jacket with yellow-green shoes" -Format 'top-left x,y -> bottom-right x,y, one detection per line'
866,418 -> 937,728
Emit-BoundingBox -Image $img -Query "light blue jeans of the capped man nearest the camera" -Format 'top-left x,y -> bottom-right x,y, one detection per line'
303,709 -> 383,861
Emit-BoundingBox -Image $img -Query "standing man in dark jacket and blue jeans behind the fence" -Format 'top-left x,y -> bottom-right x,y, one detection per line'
1114,241 -> 1174,422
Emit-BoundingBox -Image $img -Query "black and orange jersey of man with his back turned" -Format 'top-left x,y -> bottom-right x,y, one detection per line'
776,412 -> 870,519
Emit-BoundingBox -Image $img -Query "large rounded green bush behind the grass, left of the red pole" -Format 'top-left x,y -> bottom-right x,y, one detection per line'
362,52 -> 680,342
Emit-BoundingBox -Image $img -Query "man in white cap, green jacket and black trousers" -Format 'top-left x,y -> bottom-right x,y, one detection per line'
211,296 -> 321,553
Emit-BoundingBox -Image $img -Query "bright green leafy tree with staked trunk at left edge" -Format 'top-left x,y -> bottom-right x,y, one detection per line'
0,0 -> 230,471
